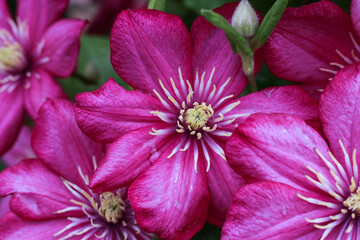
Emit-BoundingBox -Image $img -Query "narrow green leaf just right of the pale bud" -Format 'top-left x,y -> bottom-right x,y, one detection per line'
250,0 -> 289,51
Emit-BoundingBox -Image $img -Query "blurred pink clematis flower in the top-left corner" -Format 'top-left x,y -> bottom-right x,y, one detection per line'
0,0 -> 85,155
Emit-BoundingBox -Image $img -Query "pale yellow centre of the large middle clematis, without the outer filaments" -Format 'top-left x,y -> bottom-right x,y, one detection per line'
185,102 -> 214,131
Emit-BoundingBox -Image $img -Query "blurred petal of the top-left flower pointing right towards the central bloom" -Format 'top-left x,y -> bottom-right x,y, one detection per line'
40,19 -> 86,78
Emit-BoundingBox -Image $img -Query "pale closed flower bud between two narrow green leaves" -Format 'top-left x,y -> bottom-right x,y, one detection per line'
231,0 -> 259,37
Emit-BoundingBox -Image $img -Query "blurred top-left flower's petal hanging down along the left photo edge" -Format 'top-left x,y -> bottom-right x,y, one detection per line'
0,88 -> 24,155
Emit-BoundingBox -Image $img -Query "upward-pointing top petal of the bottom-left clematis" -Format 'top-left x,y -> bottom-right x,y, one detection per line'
32,100 -> 102,186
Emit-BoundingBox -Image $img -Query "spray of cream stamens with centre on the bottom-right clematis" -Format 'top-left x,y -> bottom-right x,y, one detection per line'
298,140 -> 360,239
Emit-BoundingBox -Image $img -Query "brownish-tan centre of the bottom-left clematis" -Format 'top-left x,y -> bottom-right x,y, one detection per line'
99,192 -> 125,223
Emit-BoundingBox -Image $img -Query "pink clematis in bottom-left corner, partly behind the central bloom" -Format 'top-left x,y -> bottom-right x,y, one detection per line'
0,100 -> 152,240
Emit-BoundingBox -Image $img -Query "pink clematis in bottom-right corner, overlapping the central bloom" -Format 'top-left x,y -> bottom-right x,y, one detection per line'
222,64 -> 360,240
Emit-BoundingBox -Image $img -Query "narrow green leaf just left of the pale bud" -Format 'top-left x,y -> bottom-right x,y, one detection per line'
201,9 -> 253,56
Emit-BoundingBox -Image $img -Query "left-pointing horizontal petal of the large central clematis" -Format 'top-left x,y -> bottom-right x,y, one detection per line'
75,78 -> 166,142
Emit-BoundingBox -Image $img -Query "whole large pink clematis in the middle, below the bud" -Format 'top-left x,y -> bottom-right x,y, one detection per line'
76,3 -> 317,239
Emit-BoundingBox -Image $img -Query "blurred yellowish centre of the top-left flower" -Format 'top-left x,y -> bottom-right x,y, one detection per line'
0,30 -> 26,71
